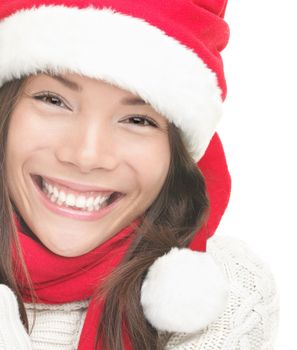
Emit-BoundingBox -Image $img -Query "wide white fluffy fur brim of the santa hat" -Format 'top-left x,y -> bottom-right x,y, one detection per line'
0,6 -> 222,161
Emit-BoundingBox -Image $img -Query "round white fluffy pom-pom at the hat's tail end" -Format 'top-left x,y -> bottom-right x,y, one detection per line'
141,247 -> 229,333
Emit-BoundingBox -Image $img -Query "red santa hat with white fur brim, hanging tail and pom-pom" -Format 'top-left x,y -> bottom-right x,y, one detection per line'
0,0 -> 230,332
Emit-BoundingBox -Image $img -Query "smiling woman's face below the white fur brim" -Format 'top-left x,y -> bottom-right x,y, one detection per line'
6,74 -> 170,256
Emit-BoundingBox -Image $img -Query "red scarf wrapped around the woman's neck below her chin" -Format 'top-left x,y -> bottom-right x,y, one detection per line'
14,215 -> 136,350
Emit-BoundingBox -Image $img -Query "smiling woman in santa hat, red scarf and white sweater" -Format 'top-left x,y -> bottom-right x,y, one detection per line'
0,0 -> 277,350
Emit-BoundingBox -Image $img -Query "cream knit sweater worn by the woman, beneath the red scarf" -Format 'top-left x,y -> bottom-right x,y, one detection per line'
17,236 -> 279,350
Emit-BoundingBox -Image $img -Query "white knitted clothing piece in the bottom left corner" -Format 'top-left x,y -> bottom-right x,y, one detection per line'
0,284 -> 32,350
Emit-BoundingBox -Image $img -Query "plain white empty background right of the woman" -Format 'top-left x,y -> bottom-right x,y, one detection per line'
217,0 -> 297,350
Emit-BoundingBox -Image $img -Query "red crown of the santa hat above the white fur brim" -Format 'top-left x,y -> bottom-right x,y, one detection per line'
0,0 -> 229,99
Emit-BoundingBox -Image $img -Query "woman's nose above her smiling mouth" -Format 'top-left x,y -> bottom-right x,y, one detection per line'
56,122 -> 118,173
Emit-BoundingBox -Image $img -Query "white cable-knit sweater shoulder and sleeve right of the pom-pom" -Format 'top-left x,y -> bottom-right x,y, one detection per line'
161,236 -> 279,350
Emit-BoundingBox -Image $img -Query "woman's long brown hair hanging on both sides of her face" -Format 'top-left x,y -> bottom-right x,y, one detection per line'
0,78 -> 209,350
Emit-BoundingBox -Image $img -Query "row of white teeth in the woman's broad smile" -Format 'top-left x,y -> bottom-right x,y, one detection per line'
42,178 -> 110,211
